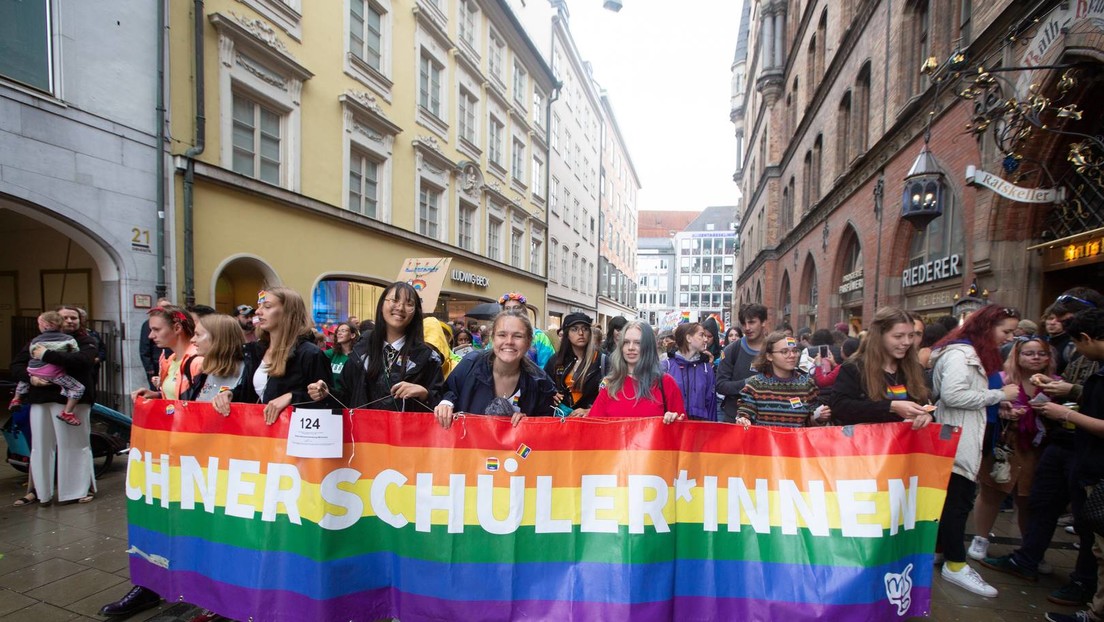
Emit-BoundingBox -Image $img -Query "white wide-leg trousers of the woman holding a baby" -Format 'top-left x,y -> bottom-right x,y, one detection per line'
31,403 -> 96,502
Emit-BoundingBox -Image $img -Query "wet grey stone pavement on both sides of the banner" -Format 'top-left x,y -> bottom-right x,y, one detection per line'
0,448 -> 1076,622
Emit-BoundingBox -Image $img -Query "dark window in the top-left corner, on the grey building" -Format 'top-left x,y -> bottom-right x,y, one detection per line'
0,0 -> 54,93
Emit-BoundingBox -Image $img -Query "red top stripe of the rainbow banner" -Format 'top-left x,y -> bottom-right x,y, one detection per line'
135,400 -> 957,457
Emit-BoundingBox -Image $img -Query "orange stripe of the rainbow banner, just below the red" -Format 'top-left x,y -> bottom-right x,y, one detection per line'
131,430 -> 948,491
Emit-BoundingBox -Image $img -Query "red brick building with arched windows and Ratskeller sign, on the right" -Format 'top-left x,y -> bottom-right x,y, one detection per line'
731,0 -> 1104,328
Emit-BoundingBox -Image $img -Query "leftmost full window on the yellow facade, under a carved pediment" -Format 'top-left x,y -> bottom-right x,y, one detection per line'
232,93 -> 284,186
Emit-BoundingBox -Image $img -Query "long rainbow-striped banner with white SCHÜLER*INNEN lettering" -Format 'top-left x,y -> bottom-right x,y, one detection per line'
126,400 -> 958,622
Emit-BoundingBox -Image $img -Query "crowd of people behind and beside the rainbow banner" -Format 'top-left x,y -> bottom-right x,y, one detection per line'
13,283 -> 1104,622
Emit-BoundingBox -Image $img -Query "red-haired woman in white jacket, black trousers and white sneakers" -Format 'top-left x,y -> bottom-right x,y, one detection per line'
932,305 -> 1020,598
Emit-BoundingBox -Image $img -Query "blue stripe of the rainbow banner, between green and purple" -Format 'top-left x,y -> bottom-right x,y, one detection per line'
129,525 -> 932,604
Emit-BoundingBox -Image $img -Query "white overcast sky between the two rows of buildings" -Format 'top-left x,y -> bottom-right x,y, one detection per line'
567,0 -> 741,211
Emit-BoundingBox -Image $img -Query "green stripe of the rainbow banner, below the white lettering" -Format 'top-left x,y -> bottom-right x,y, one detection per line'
128,502 -> 938,566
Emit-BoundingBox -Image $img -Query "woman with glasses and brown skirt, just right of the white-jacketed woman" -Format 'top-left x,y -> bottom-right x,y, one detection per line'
966,337 -> 1059,561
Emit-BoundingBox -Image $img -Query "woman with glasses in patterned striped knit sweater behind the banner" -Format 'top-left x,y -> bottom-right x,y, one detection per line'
735,330 -> 831,428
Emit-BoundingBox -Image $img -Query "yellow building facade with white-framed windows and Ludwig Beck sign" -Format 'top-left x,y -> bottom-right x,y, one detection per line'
167,0 -> 554,323
